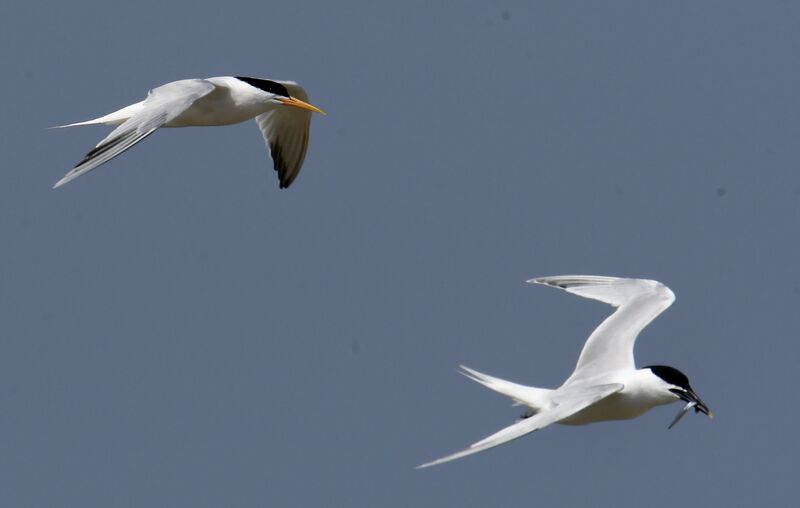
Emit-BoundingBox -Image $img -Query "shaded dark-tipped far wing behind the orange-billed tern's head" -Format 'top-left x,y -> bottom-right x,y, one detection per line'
256,81 -> 311,189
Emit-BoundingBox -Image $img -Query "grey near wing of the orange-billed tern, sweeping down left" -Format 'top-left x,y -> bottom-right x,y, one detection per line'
53,79 -> 216,189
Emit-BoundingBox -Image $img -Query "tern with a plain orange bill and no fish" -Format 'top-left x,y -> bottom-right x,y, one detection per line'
53,76 -> 325,189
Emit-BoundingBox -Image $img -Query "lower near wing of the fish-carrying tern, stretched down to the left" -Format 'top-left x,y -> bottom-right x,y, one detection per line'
416,383 -> 624,469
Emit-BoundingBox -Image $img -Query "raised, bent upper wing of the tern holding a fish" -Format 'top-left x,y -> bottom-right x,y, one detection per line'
528,275 -> 675,383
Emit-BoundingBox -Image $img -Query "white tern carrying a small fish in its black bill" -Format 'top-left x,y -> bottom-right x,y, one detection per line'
417,275 -> 713,468
